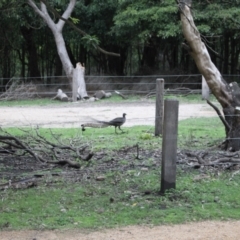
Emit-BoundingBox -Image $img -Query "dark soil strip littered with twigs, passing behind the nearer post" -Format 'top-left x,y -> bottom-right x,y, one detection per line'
0,146 -> 239,189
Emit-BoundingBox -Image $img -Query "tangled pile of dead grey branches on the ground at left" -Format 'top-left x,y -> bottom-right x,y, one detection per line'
0,129 -> 93,168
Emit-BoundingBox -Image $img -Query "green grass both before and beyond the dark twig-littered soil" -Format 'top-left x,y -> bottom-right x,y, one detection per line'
0,114 -> 240,229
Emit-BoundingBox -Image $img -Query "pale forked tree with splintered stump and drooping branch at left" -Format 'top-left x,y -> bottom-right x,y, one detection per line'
27,0 -> 122,98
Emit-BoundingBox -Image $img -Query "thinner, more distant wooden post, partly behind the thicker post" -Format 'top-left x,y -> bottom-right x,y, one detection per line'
155,78 -> 164,136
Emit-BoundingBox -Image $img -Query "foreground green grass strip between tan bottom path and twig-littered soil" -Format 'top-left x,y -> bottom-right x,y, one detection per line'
0,170 -> 240,229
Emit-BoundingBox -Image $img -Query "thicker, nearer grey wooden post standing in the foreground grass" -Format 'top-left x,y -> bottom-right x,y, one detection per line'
160,99 -> 179,194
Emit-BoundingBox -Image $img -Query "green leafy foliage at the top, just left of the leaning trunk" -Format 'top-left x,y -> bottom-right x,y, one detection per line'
112,0 -> 180,41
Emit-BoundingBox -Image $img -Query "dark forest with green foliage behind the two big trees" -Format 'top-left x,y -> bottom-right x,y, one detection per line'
0,0 -> 240,83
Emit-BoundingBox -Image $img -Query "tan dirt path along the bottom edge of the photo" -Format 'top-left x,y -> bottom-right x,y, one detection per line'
0,221 -> 240,240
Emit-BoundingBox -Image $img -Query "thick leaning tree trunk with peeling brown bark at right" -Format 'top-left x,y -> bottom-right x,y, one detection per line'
179,0 -> 240,151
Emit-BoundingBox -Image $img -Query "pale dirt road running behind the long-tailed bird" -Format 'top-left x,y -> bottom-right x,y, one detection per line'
0,102 -> 217,128
